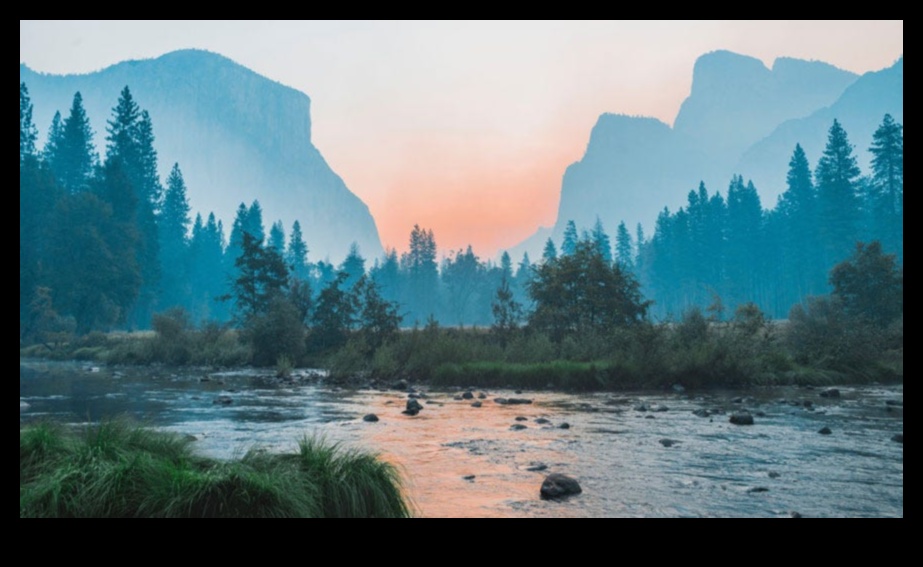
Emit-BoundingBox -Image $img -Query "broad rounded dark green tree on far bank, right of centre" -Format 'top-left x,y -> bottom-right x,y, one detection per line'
529,242 -> 648,342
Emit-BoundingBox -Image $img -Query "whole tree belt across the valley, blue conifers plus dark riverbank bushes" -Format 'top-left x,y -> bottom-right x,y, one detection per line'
20,84 -> 903,389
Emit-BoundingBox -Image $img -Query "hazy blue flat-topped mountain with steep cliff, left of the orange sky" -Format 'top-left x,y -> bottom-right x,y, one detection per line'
19,50 -> 382,262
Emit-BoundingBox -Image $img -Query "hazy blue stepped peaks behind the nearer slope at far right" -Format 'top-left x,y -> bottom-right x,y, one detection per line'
511,51 -> 860,257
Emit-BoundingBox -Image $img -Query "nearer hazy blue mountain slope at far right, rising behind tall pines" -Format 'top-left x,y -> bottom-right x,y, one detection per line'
736,56 -> 904,206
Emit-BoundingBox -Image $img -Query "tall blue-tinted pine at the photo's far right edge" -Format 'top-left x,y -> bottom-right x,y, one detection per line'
869,114 -> 904,263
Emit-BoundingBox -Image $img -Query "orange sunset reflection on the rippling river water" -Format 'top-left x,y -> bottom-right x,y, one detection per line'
354,394 -> 569,518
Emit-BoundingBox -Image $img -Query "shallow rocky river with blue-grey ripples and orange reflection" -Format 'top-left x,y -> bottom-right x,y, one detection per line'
19,360 -> 904,518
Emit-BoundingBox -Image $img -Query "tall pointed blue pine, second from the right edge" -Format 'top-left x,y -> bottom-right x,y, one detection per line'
814,120 -> 860,267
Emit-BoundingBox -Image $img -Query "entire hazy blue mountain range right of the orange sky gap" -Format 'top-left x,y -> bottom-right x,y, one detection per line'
510,51 -> 903,257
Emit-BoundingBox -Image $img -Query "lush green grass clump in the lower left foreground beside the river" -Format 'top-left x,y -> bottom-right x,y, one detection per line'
19,421 -> 411,518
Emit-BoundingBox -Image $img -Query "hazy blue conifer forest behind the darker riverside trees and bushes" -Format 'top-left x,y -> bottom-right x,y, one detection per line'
19,83 -> 904,340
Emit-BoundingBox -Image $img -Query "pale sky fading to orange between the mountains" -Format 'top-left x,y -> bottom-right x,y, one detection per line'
19,20 -> 904,257
